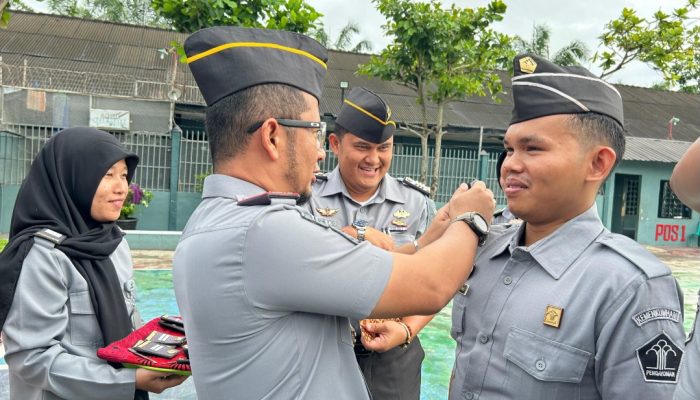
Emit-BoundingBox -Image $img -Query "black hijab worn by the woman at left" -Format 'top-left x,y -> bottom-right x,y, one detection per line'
0,128 -> 146,394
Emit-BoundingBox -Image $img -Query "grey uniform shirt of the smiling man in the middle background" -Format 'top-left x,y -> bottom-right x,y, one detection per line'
308,167 -> 436,246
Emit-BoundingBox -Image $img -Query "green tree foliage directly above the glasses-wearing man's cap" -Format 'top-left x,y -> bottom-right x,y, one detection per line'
152,0 -> 321,33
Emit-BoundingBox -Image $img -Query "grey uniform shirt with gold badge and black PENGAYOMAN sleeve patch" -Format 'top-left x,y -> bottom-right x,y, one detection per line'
449,205 -> 685,400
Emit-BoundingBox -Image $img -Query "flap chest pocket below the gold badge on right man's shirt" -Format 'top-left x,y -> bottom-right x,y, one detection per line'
503,327 -> 592,392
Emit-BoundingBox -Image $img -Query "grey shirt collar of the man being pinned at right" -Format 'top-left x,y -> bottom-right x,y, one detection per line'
492,204 -> 605,279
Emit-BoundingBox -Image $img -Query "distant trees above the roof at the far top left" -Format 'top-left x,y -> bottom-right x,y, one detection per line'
38,0 -> 169,28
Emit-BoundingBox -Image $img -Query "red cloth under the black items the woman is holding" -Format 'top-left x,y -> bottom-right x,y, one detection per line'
97,317 -> 192,375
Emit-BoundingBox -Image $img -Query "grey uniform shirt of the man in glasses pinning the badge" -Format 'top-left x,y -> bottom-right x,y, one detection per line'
173,175 -> 392,400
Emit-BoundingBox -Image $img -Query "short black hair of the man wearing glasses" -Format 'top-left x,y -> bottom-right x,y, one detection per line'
206,84 -> 307,170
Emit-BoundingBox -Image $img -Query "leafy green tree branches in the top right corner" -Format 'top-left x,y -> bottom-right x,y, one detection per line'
593,0 -> 700,91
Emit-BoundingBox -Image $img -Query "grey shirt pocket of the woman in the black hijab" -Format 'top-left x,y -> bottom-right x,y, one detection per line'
68,290 -> 102,346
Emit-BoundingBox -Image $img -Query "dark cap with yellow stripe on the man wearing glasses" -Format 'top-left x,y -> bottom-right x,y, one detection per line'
185,26 -> 328,106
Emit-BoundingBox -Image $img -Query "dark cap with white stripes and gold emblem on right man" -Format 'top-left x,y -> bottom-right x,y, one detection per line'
510,54 -> 624,126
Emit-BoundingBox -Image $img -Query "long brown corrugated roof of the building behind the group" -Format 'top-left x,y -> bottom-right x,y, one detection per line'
0,11 -> 700,145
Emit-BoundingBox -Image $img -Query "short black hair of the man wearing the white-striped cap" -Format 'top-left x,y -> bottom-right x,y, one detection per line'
569,112 -> 625,171
